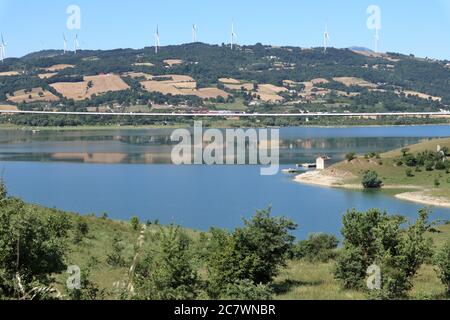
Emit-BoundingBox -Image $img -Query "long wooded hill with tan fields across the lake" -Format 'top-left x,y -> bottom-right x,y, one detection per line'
0,43 -> 450,120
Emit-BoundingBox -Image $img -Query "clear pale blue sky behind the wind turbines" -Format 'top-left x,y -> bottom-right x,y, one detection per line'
0,0 -> 450,59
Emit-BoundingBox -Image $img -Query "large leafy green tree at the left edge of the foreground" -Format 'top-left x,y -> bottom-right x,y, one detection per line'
0,190 -> 67,298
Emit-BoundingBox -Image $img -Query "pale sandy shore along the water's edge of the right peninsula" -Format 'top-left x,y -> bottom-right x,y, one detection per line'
294,169 -> 450,208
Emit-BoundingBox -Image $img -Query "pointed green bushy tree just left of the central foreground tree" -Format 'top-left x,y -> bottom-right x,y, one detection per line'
133,226 -> 200,300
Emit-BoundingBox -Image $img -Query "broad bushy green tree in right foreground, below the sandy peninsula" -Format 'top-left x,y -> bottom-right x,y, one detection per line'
335,210 -> 431,299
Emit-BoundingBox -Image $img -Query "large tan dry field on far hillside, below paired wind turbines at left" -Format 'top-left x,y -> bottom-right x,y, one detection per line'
50,74 -> 129,100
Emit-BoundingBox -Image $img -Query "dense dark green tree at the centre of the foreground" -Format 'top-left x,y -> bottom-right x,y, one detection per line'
207,208 -> 297,294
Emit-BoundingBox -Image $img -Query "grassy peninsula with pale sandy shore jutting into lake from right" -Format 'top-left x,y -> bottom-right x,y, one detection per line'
296,138 -> 450,207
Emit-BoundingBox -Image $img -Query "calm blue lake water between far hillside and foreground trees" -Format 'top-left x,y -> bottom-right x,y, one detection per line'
0,126 -> 450,238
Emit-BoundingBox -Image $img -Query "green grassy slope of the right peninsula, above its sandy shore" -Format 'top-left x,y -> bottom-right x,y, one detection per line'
332,138 -> 450,197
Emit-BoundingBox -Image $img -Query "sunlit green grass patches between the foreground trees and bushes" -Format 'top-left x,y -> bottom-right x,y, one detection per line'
28,201 -> 450,300
